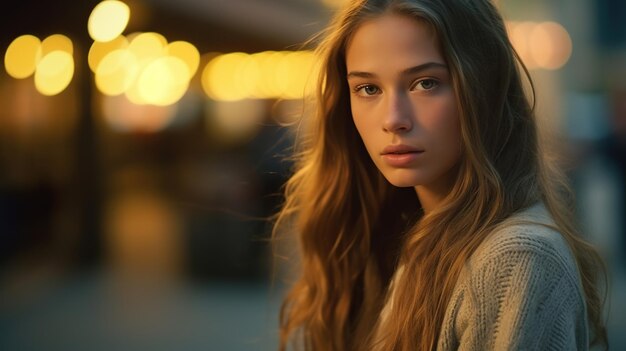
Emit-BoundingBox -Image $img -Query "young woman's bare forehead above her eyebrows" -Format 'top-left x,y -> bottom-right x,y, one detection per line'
346,14 -> 445,72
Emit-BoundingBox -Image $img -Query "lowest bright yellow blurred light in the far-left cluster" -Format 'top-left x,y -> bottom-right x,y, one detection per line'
35,50 -> 74,95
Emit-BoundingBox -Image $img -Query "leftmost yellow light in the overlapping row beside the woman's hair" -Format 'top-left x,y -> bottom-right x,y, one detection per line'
202,52 -> 249,101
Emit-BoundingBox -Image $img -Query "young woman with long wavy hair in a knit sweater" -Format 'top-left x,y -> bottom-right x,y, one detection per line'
275,0 -> 606,350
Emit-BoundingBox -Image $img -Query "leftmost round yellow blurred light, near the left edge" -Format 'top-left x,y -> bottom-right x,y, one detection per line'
4,34 -> 41,79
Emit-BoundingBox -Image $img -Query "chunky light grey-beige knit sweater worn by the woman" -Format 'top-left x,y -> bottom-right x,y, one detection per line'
381,204 -> 589,351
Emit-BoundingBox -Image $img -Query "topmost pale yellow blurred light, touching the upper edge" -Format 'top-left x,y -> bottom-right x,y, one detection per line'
87,0 -> 130,41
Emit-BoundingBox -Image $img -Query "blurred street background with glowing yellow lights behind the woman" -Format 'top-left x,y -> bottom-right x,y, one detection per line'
0,0 -> 626,350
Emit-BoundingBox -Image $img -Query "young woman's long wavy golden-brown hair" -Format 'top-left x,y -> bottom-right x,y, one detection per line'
274,0 -> 607,350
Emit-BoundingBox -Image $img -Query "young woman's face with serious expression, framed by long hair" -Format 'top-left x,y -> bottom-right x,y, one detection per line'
346,14 -> 461,193
